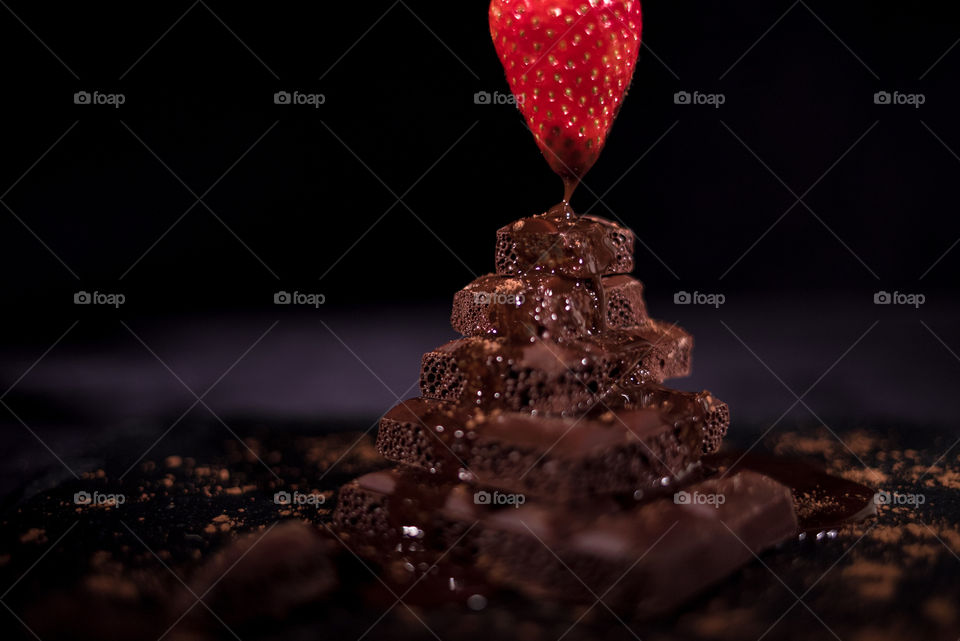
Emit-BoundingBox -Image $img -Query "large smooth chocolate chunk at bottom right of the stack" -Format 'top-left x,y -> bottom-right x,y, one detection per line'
477,471 -> 797,616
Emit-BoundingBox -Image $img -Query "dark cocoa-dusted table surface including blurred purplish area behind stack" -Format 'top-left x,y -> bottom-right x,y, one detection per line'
0,308 -> 960,641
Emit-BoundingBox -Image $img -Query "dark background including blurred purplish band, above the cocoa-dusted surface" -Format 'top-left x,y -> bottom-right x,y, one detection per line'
0,0 -> 960,464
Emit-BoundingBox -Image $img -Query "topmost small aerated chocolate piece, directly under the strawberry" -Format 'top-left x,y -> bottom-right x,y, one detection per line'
496,212 -> 633,278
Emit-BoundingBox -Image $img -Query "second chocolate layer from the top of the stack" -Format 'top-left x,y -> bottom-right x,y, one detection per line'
450,273 -> 650,340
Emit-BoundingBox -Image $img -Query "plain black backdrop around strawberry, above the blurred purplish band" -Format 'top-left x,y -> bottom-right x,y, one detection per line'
0,0 -> 960,324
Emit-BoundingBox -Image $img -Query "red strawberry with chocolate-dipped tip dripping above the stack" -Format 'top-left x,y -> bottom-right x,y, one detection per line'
490,0 -> 642,200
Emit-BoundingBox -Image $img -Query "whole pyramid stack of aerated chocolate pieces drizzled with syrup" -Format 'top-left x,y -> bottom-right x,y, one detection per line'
334,207 -> 797,613
